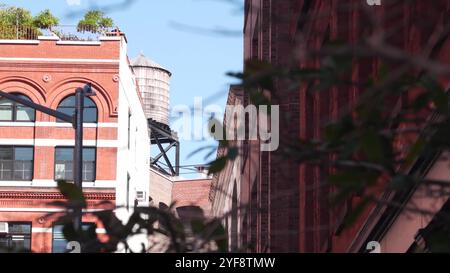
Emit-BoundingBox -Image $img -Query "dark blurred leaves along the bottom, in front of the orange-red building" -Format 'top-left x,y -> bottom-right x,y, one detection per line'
47,181 -> 228,253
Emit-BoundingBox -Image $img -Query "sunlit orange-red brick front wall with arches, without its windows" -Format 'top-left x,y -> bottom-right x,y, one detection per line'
0,33 -> 150,252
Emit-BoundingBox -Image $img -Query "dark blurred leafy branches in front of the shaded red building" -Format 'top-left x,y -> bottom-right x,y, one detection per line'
204,2 -> 450,251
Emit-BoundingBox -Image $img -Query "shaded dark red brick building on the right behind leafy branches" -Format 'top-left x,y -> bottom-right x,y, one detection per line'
210,0 -> 450,252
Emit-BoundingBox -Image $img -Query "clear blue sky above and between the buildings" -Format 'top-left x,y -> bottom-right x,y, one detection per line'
0,0 -> 243,177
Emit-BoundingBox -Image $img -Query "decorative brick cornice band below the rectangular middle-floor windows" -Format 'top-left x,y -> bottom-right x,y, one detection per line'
0,191 -> 116,201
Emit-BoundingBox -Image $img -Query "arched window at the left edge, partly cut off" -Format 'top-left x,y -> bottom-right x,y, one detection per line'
0,94 -> 35,122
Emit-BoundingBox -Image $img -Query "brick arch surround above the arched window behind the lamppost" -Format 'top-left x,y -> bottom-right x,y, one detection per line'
47,78 -> 117,122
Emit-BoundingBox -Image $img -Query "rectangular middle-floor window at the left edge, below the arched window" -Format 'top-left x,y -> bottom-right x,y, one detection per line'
0,146 -> 33,181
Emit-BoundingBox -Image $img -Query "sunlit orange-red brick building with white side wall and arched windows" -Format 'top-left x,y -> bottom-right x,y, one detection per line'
0,29 -> 150,252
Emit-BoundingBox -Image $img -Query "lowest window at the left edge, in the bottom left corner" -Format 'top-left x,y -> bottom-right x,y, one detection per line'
0,222 -> 31,253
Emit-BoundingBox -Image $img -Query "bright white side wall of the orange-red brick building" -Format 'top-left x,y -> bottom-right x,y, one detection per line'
116,36 -> 150,251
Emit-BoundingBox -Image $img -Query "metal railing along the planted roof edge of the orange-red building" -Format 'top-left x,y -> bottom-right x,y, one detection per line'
0,25 -> 120,41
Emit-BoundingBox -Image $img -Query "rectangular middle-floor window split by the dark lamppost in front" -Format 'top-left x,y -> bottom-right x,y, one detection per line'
55,147 -> 96,182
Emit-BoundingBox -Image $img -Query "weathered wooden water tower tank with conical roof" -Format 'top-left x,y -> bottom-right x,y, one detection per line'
131,52 -> 172,125
